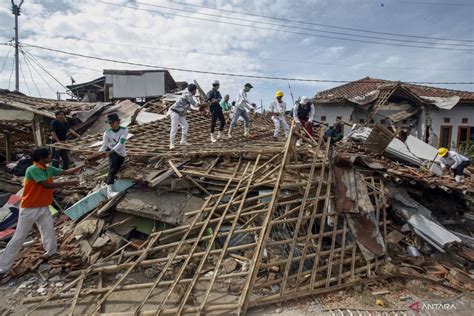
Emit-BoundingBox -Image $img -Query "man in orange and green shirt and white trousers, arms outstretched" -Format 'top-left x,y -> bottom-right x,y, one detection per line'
0,148 -> 83,274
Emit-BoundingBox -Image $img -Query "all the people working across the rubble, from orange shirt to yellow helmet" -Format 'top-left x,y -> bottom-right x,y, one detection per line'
0,81 -> 470,276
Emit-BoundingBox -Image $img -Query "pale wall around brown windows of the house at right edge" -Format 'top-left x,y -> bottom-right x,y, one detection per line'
431,103 -> 474,148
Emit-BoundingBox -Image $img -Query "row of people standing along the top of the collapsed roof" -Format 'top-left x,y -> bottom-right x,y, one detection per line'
168,80 -> 343,150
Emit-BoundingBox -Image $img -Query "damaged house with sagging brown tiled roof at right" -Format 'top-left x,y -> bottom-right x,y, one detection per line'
315,77 -> 474,148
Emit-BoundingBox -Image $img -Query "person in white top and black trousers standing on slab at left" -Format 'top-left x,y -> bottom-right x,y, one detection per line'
99,113 -> 128,199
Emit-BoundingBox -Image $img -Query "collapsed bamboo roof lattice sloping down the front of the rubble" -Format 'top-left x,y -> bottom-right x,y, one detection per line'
25,127 -> 386,315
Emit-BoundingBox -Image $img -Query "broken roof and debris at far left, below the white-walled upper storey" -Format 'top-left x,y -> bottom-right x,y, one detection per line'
0,90 -> 167,161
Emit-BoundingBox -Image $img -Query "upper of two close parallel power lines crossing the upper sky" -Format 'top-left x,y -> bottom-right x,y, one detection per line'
164,0 -> 474,42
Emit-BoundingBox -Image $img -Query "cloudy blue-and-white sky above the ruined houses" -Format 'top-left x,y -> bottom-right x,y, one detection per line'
0,0 -> 474,105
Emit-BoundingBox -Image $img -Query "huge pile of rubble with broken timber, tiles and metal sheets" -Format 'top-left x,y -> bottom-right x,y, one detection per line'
0,96 -> 474,315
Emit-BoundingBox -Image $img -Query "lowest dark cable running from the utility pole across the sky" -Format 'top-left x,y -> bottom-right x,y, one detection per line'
19,44 -> 474,85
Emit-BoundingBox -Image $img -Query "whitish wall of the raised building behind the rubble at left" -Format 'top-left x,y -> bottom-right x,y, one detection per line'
105,72 -> 166,99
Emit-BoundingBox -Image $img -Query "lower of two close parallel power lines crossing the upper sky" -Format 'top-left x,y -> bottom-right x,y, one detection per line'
97,1 -> 473,52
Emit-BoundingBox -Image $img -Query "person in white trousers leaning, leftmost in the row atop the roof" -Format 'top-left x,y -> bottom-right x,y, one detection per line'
168,83 -> 199,150
